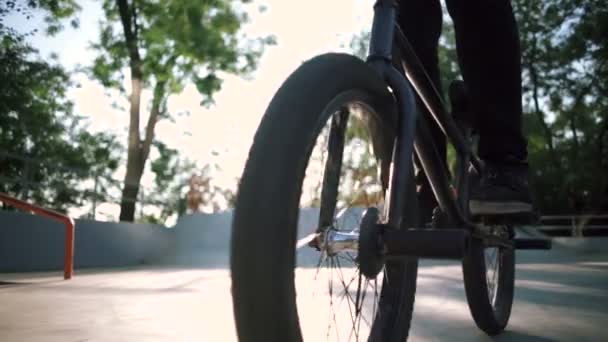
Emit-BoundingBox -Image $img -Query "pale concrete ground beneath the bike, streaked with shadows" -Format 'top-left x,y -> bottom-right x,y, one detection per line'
0,239 -> 608,342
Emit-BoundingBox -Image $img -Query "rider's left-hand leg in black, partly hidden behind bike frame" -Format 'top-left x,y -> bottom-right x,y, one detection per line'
399,0 -> 446,222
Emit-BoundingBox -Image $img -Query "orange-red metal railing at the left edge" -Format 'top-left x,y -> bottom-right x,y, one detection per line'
0,192 -> 75,279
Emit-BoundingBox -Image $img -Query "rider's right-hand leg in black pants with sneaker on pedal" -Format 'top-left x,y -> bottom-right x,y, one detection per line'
446,0 -> 532,214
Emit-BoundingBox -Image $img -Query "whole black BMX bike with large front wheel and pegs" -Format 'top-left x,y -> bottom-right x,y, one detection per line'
231,0 -> 550,342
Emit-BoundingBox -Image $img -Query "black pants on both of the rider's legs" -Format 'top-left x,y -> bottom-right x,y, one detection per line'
399,0 -> 527,218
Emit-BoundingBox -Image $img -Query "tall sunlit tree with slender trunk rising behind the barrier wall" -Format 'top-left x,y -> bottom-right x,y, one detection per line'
91,0 -> 273,221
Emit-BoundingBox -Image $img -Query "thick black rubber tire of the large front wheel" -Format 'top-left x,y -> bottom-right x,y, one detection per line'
231,54 -> 417,342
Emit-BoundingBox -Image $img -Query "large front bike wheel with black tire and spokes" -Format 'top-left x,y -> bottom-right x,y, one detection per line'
231,54 -> 417,342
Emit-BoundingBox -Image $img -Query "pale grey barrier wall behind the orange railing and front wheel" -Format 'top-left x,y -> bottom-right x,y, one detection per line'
0,208 -> 368,272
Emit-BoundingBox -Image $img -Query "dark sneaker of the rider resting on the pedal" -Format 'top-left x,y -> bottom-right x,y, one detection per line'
469,161 -> 533,216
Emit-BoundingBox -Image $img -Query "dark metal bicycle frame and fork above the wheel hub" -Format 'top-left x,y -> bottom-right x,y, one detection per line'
367,0 -> 482,230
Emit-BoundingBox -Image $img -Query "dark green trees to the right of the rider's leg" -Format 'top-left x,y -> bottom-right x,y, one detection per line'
514,0 -> 608,212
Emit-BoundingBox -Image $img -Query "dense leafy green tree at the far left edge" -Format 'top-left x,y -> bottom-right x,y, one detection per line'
0,1 -> 118,209
